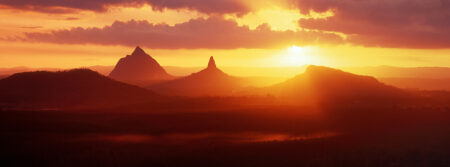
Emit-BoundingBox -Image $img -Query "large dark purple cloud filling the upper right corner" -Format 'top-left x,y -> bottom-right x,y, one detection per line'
290,0 -> 450,48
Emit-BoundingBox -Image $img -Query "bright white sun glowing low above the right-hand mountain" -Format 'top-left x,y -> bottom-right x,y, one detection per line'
282,45 -> 314,66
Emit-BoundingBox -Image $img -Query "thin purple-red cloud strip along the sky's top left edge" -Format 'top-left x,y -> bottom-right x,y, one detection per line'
0,0 -> 249,14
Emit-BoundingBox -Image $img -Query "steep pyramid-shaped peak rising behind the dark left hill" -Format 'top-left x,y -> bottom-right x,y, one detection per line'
109,46 -> 174,84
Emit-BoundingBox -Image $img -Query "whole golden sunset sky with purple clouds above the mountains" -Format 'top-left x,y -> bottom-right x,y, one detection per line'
0,0 -> 450,68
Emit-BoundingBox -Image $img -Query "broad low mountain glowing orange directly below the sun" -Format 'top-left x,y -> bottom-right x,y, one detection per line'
269,65 -> 406,103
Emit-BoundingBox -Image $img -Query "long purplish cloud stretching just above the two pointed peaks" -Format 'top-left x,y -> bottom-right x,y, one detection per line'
20,17 -> 343,49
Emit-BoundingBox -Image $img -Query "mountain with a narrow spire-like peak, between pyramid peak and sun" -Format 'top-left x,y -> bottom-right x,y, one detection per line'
149,56 -> 244,96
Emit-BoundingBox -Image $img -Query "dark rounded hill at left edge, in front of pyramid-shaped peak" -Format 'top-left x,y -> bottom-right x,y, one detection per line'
0,69 -> 157,108
